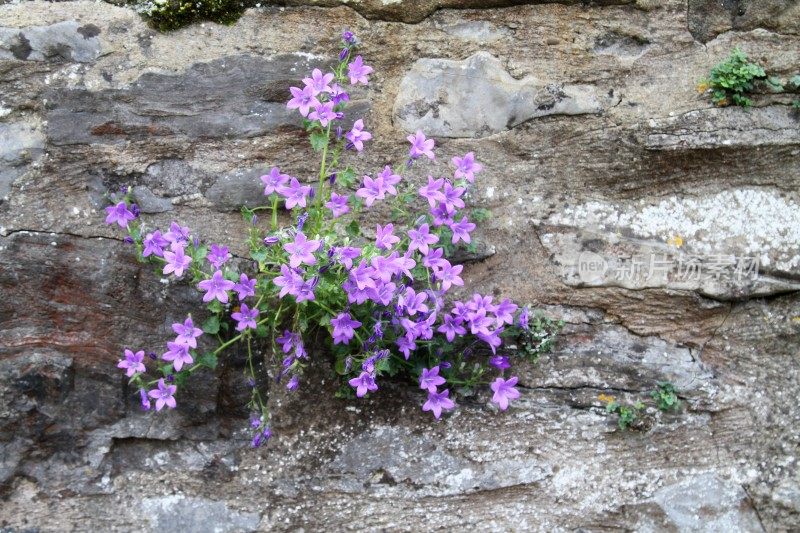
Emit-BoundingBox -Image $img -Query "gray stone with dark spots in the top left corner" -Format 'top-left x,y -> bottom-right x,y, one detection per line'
0,20 -> 102,63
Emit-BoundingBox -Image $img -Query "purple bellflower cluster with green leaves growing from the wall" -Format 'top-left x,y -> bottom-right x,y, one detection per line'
106,32 -> 560,446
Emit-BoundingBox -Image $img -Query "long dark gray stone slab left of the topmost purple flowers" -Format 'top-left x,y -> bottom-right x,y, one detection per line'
47,54 -> 324,145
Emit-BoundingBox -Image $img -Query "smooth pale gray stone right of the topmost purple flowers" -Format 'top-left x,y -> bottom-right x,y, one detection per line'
394,52 -> 602,137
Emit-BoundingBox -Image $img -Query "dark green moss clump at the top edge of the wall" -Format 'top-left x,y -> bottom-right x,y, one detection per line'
130,0 -> 254,31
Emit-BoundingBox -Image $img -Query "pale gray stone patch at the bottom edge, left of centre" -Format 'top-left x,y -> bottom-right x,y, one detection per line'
142,495 -> 261,533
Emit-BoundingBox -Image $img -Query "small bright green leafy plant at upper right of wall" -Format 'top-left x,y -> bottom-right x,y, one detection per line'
698,48 -> 767,107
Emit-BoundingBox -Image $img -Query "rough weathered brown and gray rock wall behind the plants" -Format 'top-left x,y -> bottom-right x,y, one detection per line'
0,0 -> 800,531
